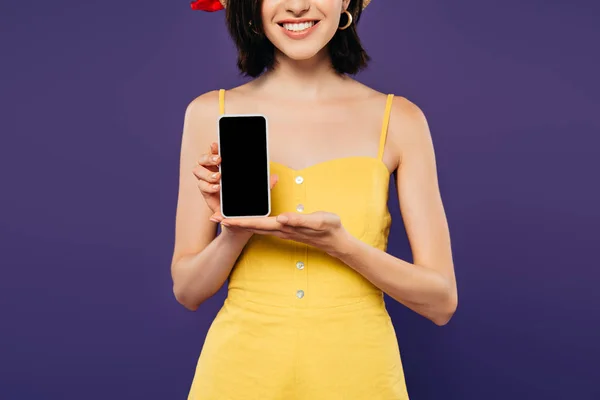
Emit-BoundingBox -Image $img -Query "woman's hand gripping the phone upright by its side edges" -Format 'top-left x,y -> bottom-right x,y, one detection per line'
193,142 -> 277,222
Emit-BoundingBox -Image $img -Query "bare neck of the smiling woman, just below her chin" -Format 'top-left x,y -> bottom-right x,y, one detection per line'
256,48 -> 349,100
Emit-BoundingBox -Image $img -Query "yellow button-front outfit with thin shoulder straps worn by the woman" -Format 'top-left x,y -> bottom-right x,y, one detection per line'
188,90 -> 408,400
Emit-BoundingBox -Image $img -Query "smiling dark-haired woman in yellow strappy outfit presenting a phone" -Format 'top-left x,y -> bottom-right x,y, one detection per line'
172,0 -> 457,400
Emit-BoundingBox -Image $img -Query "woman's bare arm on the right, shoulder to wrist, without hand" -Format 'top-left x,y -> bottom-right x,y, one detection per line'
330,97 -> 458,326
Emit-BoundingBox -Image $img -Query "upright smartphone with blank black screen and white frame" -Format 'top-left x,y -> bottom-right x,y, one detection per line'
218,114 -> 271,218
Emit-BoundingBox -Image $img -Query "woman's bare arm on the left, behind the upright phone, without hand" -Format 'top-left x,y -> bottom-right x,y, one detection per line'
171,91 -> 252,311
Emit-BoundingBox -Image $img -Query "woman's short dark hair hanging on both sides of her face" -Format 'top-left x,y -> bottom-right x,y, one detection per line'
225,0 -> 370,78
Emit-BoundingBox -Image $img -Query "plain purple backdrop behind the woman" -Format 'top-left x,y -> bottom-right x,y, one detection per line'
0,0 -> 600,400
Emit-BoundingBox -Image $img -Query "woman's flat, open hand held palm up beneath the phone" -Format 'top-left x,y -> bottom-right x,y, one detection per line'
221,211 -> 348,254
